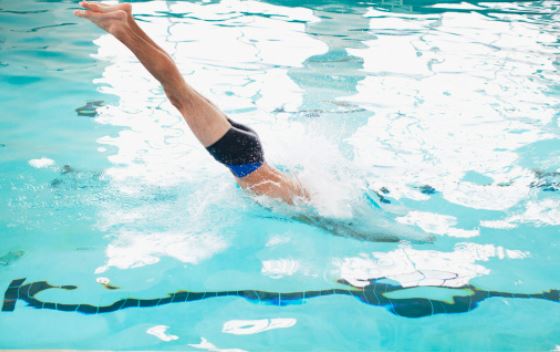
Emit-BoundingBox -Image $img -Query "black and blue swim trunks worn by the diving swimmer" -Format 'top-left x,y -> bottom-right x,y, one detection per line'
206,118 -> 264,178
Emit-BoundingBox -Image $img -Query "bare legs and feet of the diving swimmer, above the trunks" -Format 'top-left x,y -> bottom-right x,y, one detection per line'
75,2 -> 231,147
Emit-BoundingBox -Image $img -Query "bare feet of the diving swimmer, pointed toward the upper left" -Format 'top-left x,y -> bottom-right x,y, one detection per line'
74,1 -> 132,35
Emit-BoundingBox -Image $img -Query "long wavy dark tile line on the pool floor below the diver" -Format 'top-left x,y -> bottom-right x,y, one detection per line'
2,279 -> 560,318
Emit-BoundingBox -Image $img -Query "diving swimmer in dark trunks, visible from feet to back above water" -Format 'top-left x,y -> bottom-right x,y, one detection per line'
74,1 -> 309,204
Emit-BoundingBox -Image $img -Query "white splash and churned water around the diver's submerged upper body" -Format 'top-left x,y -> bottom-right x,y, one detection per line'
249,115 -> 432,242
